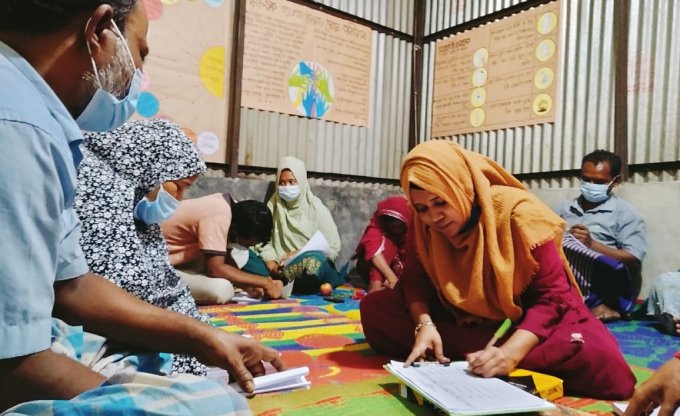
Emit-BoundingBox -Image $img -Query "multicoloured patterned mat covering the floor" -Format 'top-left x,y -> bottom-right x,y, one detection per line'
201,287 -> 680,416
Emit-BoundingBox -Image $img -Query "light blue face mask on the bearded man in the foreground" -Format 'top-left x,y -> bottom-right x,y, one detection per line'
76,21 -> 142,132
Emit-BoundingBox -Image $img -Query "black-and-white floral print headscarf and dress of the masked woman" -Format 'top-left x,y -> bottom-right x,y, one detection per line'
75,119 -> 207,375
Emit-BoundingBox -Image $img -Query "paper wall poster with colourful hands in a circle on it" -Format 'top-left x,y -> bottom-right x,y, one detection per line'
241,0 -> 372,127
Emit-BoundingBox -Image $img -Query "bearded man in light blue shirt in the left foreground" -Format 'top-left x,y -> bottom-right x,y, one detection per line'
0,0 -> 283,411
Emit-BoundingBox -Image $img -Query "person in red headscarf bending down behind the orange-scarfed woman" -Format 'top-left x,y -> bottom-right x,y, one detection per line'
354,195 -> 411,292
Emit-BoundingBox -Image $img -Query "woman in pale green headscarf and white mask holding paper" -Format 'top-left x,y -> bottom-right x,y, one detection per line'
260,156 -> 345,294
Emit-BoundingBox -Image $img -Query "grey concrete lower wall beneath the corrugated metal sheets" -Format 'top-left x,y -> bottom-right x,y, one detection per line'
187,175 -> 680,297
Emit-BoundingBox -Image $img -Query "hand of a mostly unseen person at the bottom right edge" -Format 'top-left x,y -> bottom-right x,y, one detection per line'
624,358 -> 680,416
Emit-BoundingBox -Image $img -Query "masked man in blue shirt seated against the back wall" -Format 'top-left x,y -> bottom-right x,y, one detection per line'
557,150 -> 647,321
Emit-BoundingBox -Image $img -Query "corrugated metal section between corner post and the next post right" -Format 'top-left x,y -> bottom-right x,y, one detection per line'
420,0 -> 614,187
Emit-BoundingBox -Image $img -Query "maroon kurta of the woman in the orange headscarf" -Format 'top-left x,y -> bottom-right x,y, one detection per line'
361,242 -> 635,400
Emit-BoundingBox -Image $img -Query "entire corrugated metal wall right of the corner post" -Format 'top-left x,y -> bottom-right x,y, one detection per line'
419,0 -> 680,187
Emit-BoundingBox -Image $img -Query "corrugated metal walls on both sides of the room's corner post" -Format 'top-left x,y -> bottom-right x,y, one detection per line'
239,0 -> 680,187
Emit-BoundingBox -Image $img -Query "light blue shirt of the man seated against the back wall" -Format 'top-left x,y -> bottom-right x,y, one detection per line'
557,195 -> 647,261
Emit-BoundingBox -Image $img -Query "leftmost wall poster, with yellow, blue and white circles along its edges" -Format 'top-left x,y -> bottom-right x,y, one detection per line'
135,0 -> 236,163
